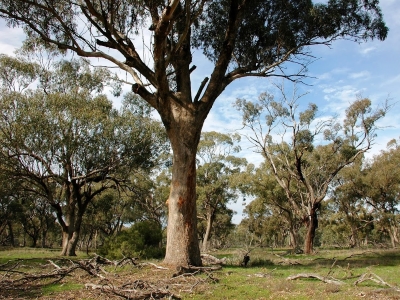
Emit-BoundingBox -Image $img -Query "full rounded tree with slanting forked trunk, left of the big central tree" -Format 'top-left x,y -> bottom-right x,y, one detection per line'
0,56 -> 166,255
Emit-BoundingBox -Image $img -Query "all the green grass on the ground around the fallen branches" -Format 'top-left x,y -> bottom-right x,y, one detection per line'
0,249 -> 400,300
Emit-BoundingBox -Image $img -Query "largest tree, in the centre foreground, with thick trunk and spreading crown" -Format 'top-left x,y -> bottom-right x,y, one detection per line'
0,0 -> 388,265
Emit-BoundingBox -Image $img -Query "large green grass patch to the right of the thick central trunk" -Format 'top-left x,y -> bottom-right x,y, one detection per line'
184,249 -> 400,300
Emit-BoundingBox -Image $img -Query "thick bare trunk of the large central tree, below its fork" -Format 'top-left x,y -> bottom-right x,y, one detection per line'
163,107 -> 204,266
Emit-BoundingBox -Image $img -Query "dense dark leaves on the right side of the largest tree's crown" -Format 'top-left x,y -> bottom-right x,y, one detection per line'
195,0 -> 388,71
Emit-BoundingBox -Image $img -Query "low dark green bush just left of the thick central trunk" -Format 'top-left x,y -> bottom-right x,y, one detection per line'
100,221 -> 165,259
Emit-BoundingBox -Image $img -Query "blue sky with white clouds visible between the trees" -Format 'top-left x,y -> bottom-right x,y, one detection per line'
0,0 -> 400,222
